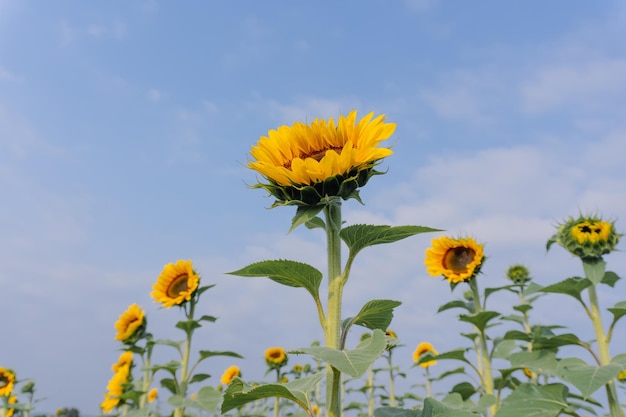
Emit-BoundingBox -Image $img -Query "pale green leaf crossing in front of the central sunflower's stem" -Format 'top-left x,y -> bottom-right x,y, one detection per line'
289,329 -> 387,378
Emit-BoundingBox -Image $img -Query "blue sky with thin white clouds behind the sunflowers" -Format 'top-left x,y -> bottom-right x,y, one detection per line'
0,0 -> 626,414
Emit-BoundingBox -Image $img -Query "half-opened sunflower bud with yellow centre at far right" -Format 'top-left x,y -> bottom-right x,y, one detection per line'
547,215 -> 623,261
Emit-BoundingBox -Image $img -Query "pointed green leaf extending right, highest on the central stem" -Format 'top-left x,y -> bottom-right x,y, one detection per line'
339,224 -> 440,258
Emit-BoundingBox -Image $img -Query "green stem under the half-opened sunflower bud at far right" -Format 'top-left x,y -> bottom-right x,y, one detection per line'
583,260 -> 622,417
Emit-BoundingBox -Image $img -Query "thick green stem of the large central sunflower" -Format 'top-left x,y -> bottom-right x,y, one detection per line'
324,200 -> 344,417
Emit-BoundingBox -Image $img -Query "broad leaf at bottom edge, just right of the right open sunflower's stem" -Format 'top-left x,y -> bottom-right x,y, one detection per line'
495,383 -> 568,417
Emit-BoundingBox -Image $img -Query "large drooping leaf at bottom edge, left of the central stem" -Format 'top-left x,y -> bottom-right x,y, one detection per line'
221,372 -> 324,414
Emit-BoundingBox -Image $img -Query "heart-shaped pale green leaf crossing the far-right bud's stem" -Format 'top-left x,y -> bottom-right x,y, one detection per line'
558,358 -> 623,398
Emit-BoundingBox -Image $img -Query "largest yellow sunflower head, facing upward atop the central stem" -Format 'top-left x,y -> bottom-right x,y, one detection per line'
248,110 -> 396,205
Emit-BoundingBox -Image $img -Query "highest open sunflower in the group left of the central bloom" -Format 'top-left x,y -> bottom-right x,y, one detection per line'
150,260 -> 200,308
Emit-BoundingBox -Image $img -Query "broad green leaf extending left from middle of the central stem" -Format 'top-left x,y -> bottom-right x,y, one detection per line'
229,259 -> 323,300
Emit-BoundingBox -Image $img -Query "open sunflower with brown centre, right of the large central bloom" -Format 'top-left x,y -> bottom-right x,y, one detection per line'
424,236 -> 485,284
